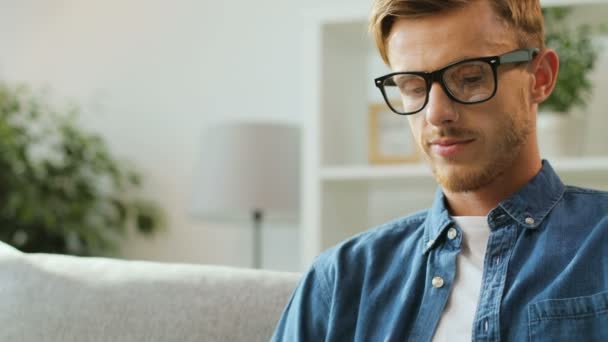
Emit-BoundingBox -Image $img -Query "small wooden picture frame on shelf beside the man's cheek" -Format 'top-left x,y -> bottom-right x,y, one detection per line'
368,102 -> 420,164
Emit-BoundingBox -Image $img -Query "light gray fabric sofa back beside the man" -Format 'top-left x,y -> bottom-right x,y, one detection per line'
0,243 -> 298,342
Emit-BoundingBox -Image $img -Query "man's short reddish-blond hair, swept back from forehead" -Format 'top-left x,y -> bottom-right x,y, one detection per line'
369,0 -> 545,64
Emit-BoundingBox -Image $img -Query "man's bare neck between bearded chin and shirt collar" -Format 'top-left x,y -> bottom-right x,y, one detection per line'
444,155 -> 542,216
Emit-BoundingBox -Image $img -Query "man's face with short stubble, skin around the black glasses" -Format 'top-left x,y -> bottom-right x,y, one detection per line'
387,1 -> 535,192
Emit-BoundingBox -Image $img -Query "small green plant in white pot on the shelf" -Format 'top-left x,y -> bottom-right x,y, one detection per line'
537,7 -> 600,157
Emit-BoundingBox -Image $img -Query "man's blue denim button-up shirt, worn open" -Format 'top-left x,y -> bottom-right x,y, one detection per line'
272,161 -> 608,342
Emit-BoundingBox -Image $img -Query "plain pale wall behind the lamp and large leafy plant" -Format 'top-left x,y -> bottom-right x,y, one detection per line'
0,0 -> 366,270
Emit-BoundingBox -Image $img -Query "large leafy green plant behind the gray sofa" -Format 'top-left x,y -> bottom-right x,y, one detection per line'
0,82 -> 164,256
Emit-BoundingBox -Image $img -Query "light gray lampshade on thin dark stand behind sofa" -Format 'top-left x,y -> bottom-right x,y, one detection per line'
193,122 -> 300,218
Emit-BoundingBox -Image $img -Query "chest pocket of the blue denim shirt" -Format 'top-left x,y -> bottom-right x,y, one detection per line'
528,291 -> 608,342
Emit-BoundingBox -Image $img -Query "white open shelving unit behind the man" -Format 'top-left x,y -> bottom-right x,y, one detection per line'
301,0 -> 608,269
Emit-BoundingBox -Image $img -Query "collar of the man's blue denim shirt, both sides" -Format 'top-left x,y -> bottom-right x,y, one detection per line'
423,160 -> 566,252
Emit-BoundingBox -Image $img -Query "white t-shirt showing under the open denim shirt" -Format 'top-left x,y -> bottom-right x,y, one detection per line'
433,216 -> 490,342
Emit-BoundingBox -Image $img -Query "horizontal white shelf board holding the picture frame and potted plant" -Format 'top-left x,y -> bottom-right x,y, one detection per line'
321,157 -> 608,182
